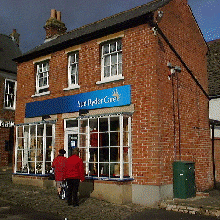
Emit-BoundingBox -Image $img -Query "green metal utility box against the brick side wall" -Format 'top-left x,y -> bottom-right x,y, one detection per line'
173,161 -> 196,199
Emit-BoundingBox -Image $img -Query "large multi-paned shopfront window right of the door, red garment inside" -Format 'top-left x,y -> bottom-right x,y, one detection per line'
66,114 -> 132,179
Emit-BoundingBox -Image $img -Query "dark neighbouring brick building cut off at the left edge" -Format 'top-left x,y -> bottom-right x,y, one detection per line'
0,29 -> 21,167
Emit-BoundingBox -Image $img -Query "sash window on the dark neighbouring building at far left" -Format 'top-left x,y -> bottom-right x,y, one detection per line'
4,79 -> 16,109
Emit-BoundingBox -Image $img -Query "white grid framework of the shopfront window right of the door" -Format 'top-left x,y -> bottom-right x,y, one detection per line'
64,114 -> 132,180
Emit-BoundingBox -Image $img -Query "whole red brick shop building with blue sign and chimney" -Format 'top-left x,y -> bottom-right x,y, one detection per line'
14,0 -> 213,205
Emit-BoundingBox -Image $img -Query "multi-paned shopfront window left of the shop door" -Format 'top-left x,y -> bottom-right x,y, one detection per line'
15,123 -> 55,174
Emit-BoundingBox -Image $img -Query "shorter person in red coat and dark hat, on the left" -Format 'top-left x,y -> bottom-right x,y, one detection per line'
52,149 -> 67,196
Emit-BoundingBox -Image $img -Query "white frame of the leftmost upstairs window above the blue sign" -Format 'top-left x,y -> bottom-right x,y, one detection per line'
36,60 -> 50,95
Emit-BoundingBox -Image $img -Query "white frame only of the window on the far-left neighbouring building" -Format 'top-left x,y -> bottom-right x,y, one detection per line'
4,79 -> 17,110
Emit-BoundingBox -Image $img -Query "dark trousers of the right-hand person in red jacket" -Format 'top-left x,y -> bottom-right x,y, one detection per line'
67,179 -> 80,205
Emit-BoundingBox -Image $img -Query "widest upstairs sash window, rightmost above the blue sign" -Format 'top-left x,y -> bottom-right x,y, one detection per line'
101,39 -> 122,81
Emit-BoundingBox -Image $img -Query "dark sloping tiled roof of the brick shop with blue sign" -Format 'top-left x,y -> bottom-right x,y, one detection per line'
16,0 -> 171,62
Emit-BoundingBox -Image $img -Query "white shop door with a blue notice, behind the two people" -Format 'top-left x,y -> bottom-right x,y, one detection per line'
64,131 -> 78,157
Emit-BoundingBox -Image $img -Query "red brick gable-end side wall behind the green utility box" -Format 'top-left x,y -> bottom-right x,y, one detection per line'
150,0 -> 213,190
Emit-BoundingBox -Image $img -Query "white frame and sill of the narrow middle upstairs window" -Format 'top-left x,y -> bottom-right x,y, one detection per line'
64,50 -> 80,90
